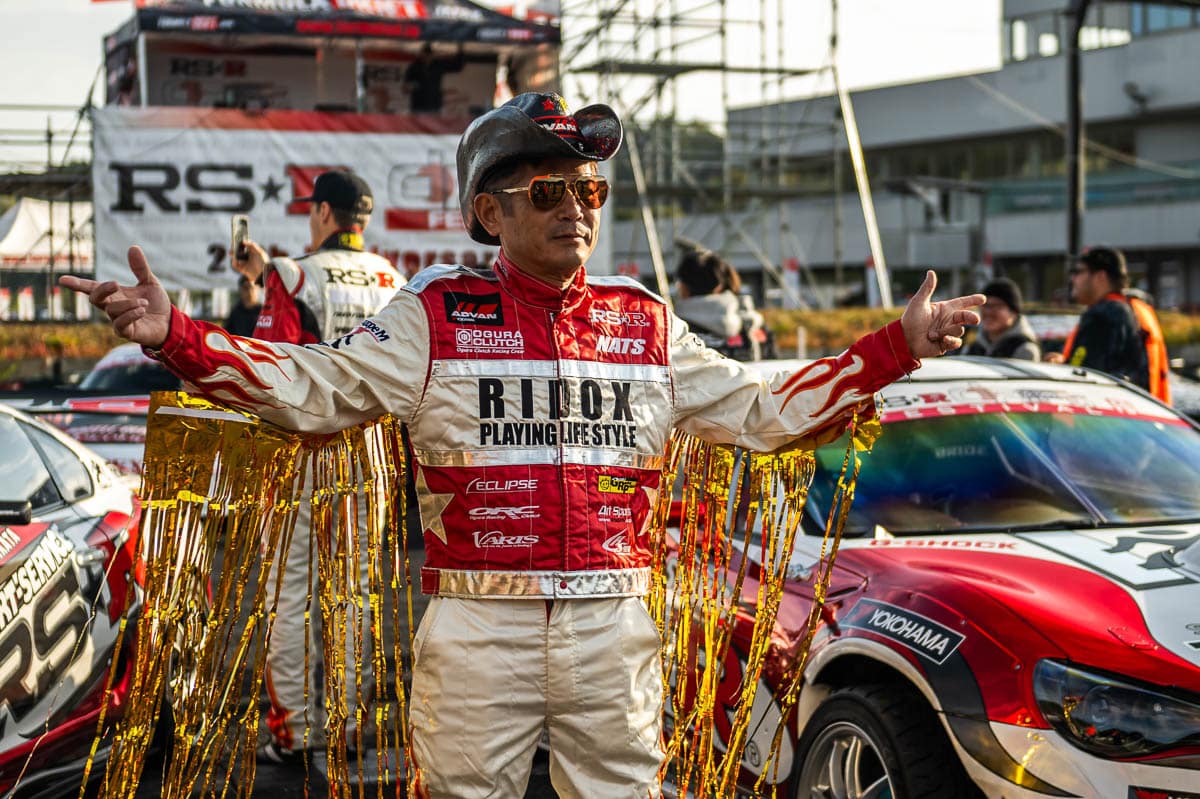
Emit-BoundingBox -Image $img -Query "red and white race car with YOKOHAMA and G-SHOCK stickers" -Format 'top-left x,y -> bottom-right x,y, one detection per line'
668,358 -> 1200,799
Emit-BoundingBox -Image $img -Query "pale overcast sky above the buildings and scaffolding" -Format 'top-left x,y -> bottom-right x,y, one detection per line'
0,0 -> 1000,164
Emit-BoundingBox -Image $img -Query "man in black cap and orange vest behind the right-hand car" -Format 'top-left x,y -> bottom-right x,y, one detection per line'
1045,247 -> 1171,404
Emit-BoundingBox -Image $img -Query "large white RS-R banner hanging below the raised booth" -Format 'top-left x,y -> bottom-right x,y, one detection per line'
92,107 -> 494,292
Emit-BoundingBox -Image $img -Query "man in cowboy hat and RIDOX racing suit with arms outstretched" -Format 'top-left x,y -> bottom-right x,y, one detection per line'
62,94 -> 983,799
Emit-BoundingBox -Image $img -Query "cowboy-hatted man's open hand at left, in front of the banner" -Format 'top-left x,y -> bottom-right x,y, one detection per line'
59,247 -> 170,349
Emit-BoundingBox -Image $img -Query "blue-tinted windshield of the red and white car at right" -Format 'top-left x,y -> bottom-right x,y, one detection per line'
808,411 -> 1200,536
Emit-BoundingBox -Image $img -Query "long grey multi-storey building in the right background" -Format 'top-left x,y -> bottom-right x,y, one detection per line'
614,0 -> 1200,307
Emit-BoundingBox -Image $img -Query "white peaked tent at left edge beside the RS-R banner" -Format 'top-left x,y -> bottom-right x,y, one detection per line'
0,197 -> 94,272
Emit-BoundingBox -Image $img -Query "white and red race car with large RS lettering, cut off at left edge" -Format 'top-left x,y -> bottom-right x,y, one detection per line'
0,405 -> 142,797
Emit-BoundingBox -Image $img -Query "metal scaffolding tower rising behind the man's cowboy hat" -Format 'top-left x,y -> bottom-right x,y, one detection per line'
562,0 -> 827,304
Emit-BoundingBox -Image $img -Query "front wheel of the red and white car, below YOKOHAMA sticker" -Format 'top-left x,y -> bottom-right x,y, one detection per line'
793,683 -> 978,799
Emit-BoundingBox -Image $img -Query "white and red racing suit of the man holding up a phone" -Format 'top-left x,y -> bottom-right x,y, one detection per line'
254,229 -> 404,750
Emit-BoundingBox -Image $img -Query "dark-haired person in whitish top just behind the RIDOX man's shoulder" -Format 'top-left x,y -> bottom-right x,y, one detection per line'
674,247 -> 772,361
